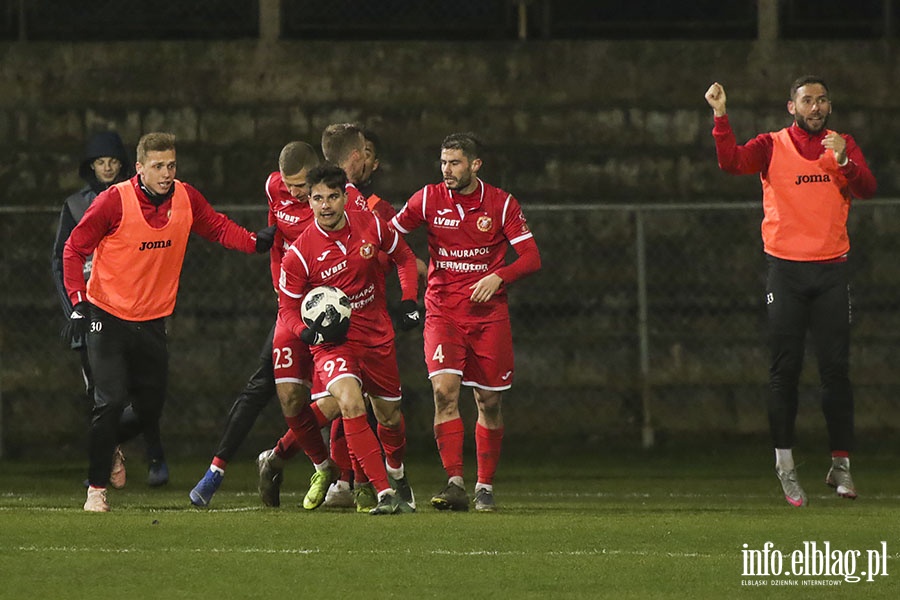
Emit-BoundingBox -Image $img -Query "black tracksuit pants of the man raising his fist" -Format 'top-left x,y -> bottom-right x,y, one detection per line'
766,256 -> 854,452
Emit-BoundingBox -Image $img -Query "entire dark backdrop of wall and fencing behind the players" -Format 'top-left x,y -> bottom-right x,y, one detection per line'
0,0 -> 900,458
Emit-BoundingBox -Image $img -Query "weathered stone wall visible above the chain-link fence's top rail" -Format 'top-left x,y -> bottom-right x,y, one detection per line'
0,41 -> 900,204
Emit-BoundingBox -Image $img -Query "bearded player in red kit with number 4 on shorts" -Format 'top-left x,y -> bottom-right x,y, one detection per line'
391,133 -> 541,512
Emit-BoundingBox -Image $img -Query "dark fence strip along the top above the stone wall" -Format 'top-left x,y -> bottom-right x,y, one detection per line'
0,0 -> 900,41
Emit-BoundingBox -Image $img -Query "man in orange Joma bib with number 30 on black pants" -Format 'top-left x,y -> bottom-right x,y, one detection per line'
63,133 -> 272,512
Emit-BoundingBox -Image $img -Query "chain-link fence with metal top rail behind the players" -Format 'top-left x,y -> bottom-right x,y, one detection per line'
0,200 -> 900,456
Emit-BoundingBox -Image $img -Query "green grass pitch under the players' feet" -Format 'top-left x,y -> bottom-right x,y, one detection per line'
0,442 -> 900,600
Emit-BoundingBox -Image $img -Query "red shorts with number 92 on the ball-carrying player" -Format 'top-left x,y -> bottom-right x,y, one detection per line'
312,340 -> 402,401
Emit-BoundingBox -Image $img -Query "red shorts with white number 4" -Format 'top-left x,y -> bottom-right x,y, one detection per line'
424,314 -> 513,391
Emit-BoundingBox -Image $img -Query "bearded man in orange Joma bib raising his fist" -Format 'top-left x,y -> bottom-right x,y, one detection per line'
705,76 -> 876,507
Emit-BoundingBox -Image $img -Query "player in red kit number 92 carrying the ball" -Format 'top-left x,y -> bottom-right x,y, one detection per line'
278,164 -> 418,515
